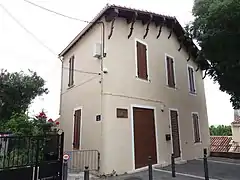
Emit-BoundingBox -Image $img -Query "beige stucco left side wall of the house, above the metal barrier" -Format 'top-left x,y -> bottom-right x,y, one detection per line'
60,23 -> 101,153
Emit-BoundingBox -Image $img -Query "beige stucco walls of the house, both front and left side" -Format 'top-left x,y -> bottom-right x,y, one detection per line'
60,16 -> 209,173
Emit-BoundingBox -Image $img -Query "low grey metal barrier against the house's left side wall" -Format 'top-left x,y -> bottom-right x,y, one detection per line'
65,150 -> 100,173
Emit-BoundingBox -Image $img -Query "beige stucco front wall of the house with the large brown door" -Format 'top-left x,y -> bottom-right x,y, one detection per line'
102,19 -> 209,173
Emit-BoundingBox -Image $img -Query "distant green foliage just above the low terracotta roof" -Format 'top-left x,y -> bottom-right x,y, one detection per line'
209,125 -> 232,136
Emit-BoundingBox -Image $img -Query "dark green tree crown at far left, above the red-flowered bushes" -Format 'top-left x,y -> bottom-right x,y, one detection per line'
0,70 -> 48,123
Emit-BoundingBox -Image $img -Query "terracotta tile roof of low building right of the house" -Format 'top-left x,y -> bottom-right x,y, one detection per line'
210,136 -> 232,152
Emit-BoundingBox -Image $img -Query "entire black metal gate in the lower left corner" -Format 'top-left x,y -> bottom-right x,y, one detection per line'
0,133 -> 64,180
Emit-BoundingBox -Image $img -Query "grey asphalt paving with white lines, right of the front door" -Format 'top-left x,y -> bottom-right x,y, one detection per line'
158,158 -> 240,180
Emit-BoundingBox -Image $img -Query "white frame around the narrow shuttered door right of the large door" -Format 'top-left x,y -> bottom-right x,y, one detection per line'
168,108 -> 182,160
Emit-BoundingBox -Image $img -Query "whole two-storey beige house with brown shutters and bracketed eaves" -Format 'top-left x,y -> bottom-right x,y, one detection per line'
60,5 -> 210,174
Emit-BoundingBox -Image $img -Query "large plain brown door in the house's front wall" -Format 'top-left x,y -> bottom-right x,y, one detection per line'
133,107 -> 157,169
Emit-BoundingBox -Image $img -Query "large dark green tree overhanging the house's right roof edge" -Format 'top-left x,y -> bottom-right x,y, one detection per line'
186,0 -> 240,109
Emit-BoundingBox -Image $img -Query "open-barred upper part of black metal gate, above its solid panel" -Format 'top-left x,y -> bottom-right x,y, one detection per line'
0,134 -> 61,170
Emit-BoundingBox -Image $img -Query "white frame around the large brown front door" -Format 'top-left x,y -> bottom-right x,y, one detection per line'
130,104 -> 159,171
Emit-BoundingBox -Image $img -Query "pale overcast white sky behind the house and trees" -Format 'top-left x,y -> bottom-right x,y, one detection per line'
0,0 -> 233,124
